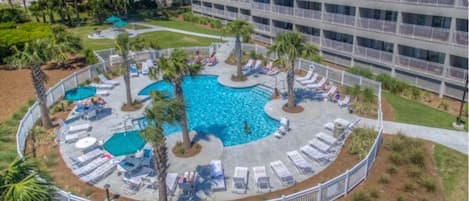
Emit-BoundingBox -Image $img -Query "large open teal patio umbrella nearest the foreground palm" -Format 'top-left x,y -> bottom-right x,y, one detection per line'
103,131 -> 145,156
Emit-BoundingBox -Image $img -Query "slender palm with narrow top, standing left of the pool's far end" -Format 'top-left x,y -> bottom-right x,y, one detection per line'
116,32 -> 132,106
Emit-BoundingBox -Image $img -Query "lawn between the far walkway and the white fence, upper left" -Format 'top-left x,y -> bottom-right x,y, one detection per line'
70,25 -> 218,50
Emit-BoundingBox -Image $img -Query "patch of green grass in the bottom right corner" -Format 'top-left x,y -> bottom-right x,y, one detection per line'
433,144 -> 468,201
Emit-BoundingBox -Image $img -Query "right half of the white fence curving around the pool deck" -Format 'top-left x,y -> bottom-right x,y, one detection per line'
239,44 -> 383,201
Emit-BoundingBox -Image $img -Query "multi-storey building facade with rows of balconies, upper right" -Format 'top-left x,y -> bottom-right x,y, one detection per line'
192,0 -> 468,98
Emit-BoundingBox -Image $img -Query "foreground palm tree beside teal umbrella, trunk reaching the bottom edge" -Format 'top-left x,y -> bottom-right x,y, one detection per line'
141,91 -> 183,201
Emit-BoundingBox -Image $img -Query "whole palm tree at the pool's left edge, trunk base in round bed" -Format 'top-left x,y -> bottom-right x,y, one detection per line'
150,49 -> 201,151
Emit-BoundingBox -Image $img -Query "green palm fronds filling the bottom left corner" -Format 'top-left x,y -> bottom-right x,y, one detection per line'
0,158 -> 55,201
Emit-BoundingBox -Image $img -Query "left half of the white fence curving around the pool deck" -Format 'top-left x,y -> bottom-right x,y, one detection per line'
16,44 -> 217,201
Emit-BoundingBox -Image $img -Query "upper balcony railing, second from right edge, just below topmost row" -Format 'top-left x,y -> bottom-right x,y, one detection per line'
400,23 -> 449,41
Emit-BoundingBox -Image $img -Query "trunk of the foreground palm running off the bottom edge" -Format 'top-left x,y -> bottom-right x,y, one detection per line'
153,141 -> 168,201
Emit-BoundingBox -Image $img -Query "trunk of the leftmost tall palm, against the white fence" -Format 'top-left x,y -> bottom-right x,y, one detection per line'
31,64 -> 52,129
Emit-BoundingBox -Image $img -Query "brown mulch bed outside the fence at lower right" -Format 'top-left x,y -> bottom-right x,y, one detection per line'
339,135 -> 444,201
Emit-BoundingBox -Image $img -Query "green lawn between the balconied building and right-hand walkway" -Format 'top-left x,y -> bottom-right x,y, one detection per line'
383,92 -> 467,130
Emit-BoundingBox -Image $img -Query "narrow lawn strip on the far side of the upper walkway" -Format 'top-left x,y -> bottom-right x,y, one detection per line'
145,19 -> 221,36
